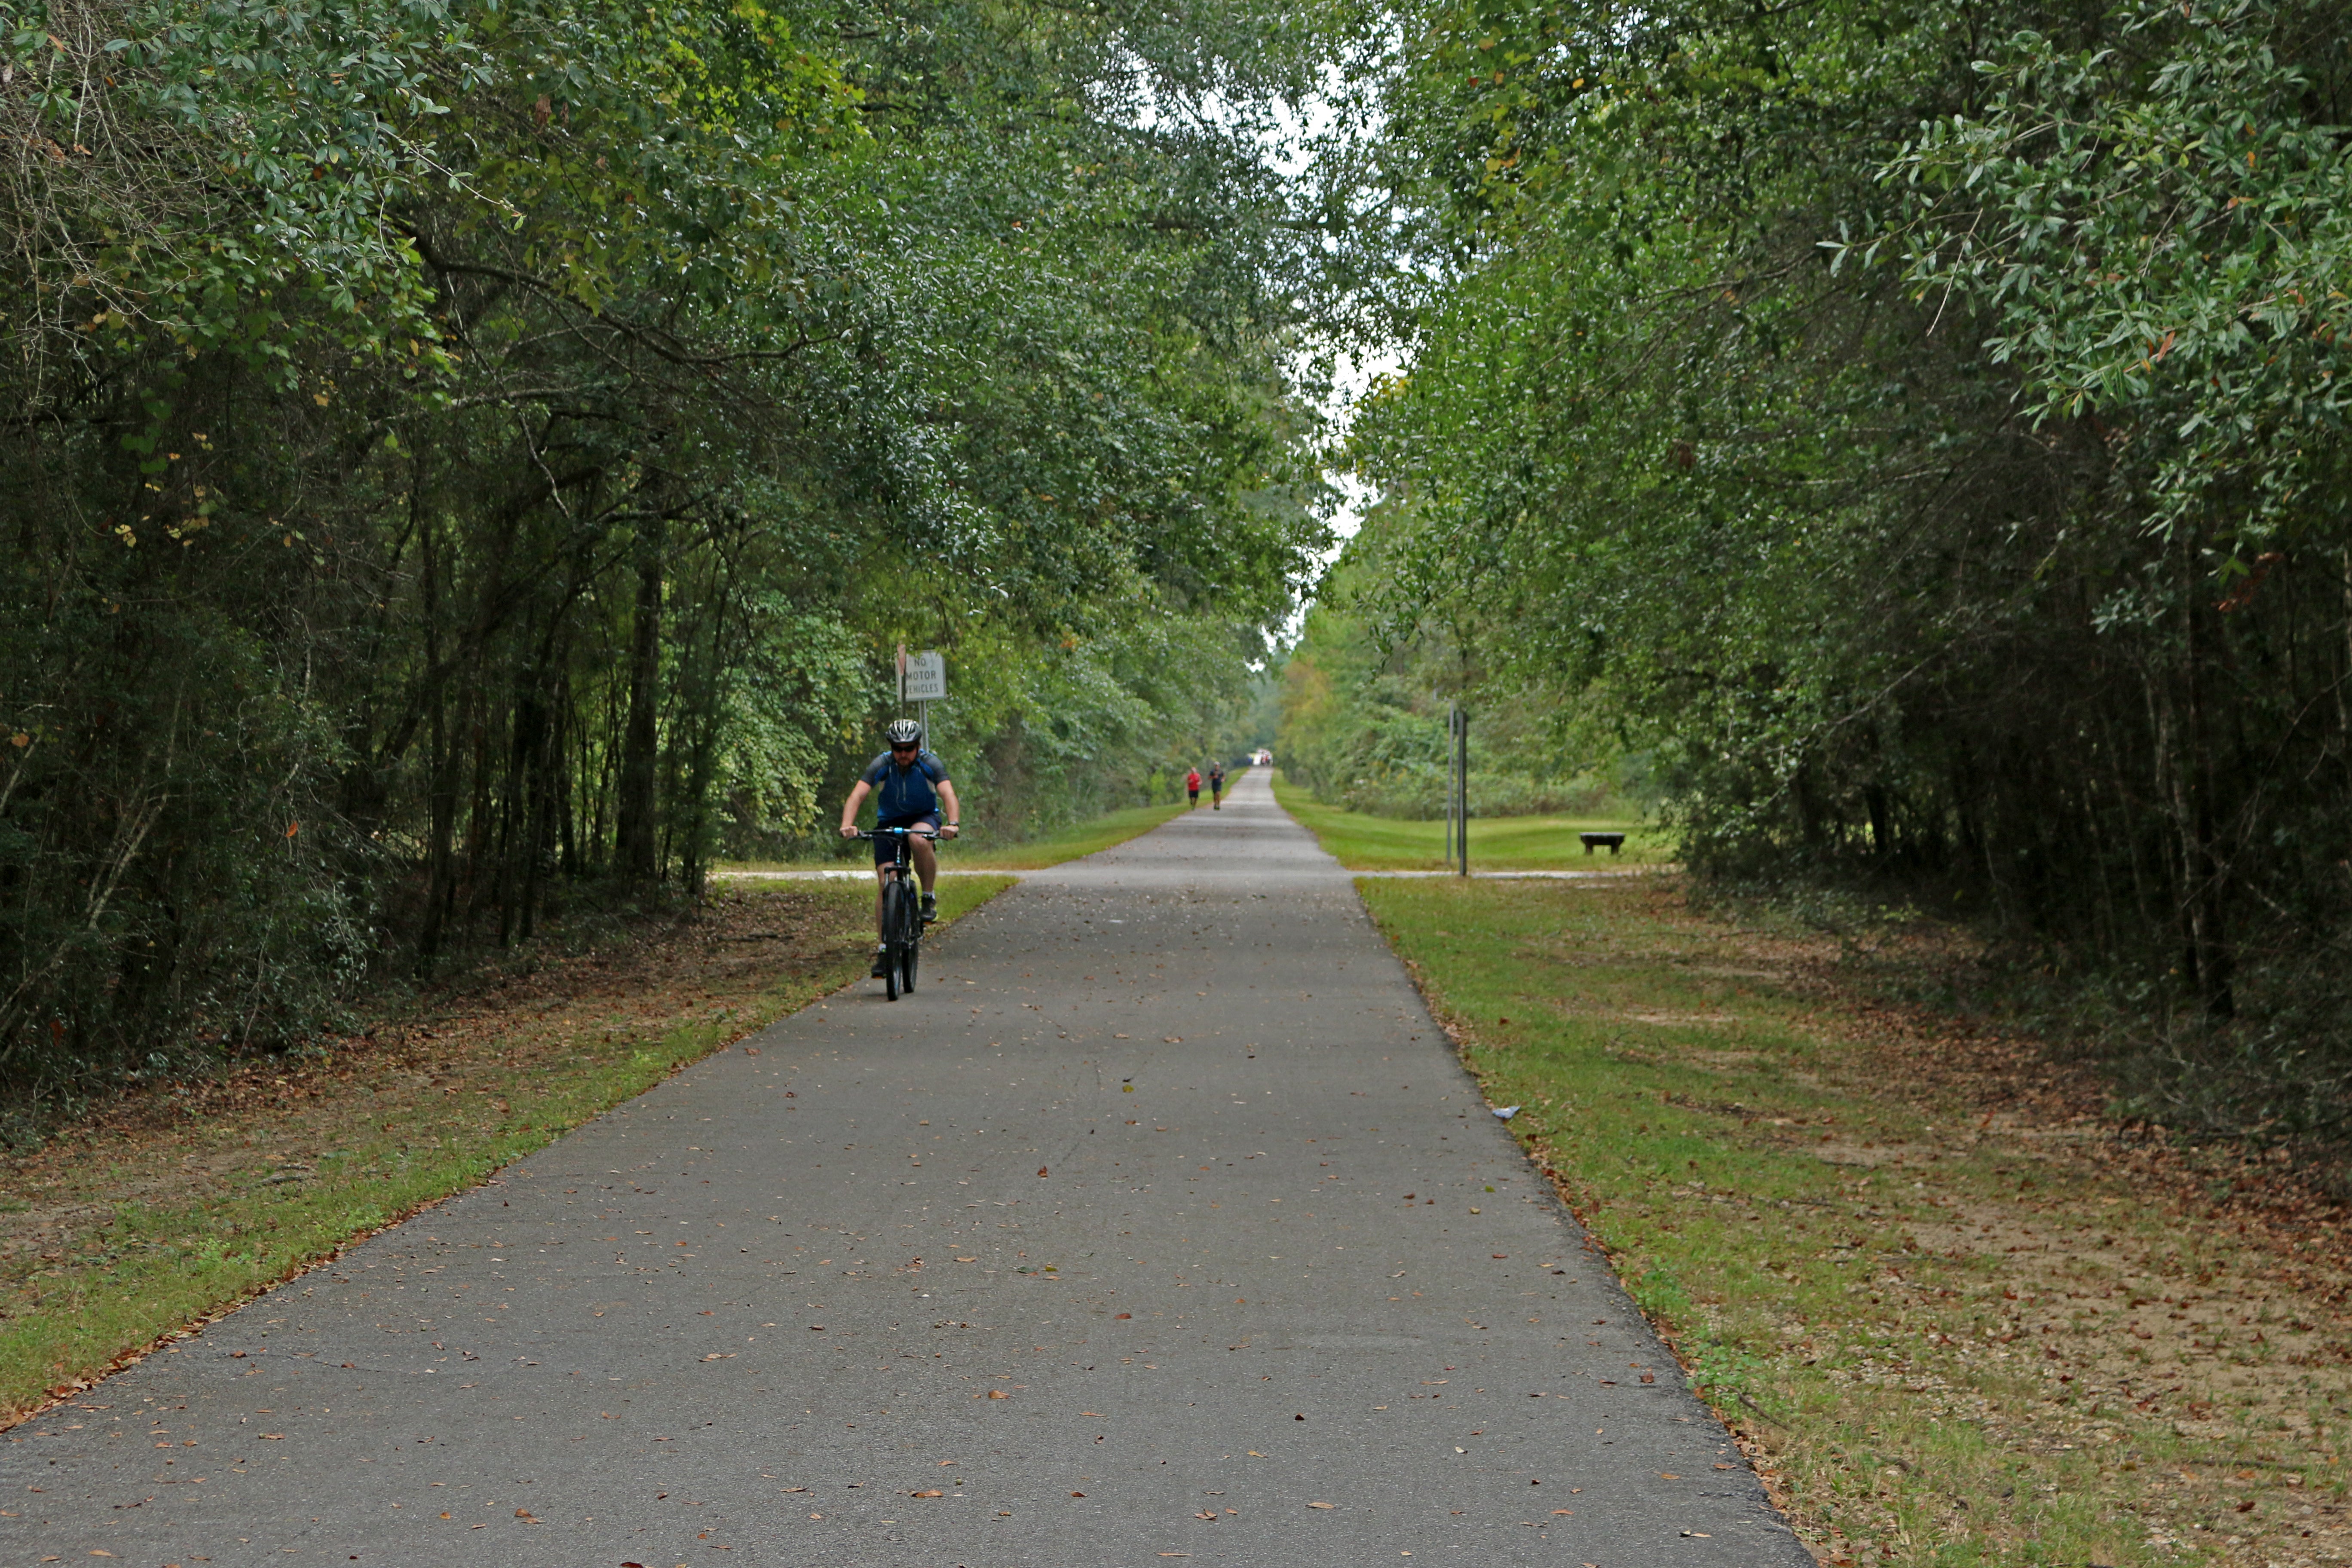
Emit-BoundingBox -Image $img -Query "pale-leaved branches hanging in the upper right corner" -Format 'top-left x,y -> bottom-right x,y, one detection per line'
1865,2 -> 2352,552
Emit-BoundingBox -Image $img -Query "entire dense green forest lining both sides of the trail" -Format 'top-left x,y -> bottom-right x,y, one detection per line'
18,0 -> 2352,1138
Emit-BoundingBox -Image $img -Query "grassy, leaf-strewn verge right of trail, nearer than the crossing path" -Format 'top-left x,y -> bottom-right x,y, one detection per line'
1357,877 -> 2352,1568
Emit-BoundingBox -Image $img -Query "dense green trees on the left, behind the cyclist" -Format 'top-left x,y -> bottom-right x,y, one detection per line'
0,0 -> 1326,1105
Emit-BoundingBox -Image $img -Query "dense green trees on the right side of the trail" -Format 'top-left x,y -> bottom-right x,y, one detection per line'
1284,0 -> 2352,1140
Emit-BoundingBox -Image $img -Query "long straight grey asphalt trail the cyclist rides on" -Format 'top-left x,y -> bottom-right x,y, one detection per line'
0,773 -> 1811,1568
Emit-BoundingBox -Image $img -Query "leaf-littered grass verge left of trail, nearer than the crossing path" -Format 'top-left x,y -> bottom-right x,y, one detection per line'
0,877 -> 1014,1427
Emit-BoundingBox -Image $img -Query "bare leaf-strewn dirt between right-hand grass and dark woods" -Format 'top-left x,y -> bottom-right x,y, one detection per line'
1743,903 -> 2352,1568
